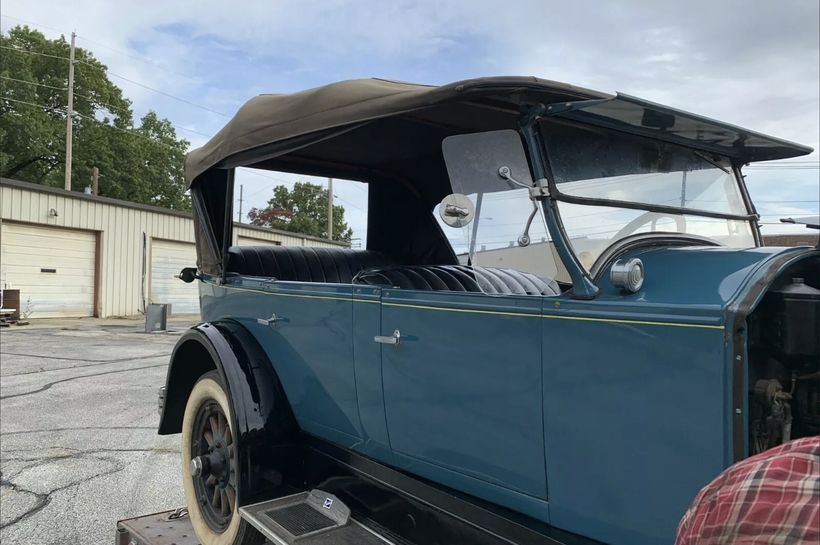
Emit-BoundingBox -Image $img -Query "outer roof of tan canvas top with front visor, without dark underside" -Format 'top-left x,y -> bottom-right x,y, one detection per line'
185,77 -> 812,186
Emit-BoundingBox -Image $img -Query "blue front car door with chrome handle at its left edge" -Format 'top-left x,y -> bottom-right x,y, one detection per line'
376,289 -> 547,520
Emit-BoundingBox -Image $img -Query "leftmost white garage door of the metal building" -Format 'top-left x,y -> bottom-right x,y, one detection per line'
0,222 -> 97,318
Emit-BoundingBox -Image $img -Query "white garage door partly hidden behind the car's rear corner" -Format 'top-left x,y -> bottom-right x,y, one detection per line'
150,239 -> 199,314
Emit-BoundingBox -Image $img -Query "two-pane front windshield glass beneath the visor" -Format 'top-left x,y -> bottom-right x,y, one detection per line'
541,120 -> 755,269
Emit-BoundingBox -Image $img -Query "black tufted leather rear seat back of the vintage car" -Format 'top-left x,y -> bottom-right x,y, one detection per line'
227,246 -> 394,284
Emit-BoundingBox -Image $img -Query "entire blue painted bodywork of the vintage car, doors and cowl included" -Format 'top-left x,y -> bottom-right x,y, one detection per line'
201,247 -> 812,545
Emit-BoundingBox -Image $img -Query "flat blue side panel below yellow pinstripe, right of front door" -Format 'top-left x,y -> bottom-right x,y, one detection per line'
542,306 -> 730,545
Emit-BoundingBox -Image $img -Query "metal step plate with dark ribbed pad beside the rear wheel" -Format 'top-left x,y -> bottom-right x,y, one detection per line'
239,489 -> 393,545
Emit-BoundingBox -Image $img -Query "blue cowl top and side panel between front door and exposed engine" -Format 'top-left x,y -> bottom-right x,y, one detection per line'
543,243 -> 810,545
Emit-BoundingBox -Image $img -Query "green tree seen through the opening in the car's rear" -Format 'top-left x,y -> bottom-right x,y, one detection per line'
248,182 -> 353,242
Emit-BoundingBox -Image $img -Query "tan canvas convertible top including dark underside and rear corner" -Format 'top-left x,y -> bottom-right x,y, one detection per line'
185,77 -> 811,276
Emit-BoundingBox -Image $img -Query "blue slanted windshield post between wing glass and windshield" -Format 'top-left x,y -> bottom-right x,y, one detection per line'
519,101 -> 601,299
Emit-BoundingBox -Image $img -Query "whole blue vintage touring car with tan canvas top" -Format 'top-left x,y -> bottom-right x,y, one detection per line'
159,77 -> 820,545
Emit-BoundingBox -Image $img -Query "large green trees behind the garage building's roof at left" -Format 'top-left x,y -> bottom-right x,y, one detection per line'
0,26 -> 191,209
